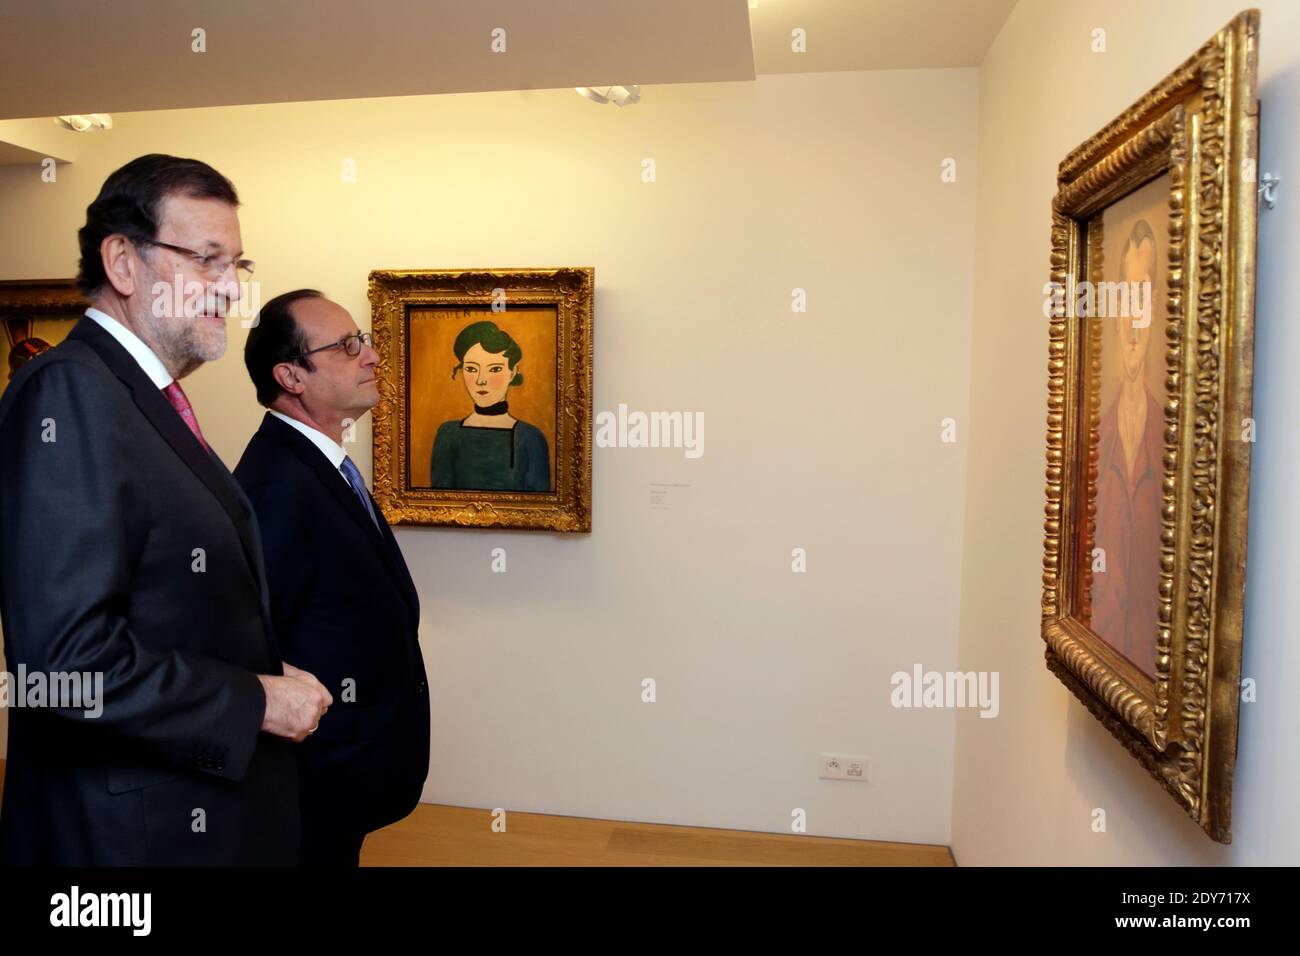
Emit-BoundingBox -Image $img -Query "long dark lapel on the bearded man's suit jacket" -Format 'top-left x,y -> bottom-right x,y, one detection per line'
68,319 -> 265,598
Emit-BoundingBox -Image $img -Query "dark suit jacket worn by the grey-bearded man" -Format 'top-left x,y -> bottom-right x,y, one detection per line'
0,319 -> 299,866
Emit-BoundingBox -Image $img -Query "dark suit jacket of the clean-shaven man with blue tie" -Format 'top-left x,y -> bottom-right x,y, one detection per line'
234,412 -> 429,834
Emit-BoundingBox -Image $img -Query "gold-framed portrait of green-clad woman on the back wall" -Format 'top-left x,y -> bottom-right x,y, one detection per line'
371,267 -> 595,532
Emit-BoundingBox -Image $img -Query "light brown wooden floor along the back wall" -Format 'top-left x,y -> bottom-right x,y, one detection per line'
0,760 -> 954,866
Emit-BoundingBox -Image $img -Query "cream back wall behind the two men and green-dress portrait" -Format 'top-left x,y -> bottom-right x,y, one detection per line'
0,69 -> 977,843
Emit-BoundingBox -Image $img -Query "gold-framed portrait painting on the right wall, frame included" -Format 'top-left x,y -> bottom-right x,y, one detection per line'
1041,10 -> 1260,843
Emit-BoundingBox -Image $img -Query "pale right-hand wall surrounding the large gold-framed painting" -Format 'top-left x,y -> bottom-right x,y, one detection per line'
952,0 -> 1300,865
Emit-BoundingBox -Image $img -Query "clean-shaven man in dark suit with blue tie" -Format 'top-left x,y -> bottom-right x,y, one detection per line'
235,289 -> 429,866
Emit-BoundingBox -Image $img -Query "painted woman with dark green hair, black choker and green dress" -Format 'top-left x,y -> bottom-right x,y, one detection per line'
429,321 -> 551,492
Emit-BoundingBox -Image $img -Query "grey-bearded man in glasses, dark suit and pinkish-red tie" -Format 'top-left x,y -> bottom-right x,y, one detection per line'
0,155 -> 332,866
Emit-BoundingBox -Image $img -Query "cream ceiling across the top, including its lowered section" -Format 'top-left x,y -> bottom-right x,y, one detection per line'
0,0 -> 1015,120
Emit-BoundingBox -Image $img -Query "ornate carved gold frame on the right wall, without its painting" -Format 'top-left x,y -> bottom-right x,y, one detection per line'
1043,10 -> 1260,843
